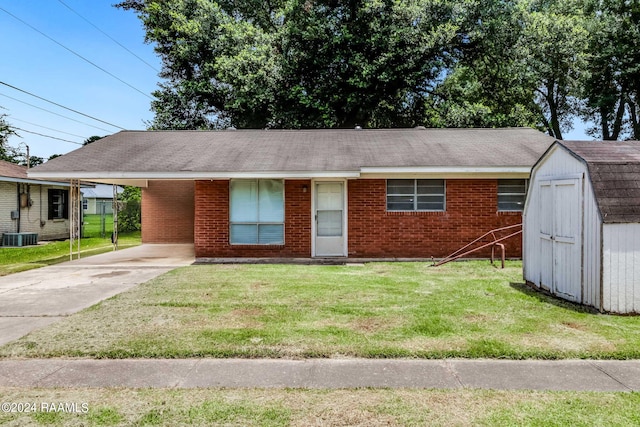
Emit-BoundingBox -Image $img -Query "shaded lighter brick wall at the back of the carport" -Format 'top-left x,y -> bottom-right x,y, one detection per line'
142,181 -> 194,243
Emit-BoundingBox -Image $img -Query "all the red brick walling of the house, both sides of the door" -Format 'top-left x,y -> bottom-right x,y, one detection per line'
148,179 -> 522,258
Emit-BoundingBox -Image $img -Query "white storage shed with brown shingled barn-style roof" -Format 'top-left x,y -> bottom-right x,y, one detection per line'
523,141 -> 640,314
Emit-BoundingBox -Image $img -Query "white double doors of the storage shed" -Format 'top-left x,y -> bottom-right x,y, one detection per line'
539,178 -> 582,302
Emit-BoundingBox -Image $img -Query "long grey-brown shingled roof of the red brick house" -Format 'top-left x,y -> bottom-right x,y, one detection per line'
30,128 -> 553,179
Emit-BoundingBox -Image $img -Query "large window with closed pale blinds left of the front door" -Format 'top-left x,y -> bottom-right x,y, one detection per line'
229,179 -> 284,245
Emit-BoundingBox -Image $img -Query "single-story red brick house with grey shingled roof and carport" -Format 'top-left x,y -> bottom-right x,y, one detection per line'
30,128 -> 554,258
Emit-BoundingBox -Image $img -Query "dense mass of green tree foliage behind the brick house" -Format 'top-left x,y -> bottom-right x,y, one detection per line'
119,0 -> 640,139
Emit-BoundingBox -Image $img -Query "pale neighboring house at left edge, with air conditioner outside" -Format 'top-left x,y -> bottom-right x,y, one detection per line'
0,160 -> 70,244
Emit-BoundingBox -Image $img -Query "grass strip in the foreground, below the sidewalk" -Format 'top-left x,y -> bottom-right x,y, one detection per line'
0,389 -> 640,427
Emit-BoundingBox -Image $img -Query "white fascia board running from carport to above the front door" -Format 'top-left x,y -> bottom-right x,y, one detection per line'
30,171 -> 360,182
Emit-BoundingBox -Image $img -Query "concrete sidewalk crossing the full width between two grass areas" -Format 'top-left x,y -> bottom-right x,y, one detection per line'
0,359 -> 640,392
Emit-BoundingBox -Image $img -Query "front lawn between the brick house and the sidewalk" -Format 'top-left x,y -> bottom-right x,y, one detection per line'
0,261 -> 640,359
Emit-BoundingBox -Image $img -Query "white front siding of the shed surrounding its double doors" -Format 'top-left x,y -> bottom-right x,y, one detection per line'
523,146 -> 600,308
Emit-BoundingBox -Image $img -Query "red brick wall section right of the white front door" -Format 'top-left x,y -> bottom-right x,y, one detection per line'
348,179 -> 522,258
